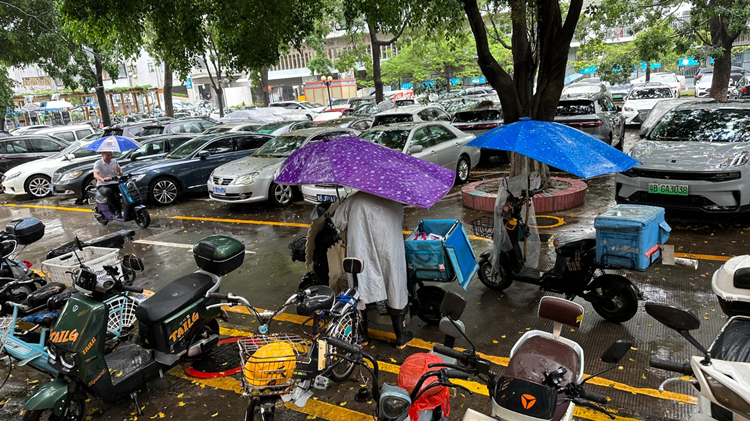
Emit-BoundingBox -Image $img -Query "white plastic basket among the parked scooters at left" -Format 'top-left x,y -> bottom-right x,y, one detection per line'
42,247 -> 120,286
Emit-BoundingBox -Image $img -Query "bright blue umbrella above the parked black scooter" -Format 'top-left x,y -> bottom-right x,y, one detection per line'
467,117 -> 640,178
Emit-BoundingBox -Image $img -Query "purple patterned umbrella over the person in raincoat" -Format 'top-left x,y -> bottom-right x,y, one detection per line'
275,137 -> 456,208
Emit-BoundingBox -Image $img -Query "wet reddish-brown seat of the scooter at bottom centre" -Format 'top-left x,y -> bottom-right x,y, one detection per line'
505,336 -> 581,386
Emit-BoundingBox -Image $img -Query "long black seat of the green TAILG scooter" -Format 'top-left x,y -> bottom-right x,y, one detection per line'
135,272 -> 214,325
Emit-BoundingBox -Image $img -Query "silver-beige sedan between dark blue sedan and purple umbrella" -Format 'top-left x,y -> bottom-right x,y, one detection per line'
208,127 -> 356,207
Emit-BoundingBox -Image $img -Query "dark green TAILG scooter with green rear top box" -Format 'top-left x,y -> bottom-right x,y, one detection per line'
23,235 -> 245,421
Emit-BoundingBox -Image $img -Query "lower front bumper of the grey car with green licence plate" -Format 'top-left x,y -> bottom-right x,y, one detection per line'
615,174 -> 750,213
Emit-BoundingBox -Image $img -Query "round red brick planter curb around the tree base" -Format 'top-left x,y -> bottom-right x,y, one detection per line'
461,177 -> 587,213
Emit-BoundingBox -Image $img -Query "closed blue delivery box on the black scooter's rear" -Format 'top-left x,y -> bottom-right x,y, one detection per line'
594,205 -> 671,270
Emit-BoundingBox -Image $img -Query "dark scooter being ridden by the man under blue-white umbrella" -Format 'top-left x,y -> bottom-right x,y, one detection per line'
86,174 -> 151,228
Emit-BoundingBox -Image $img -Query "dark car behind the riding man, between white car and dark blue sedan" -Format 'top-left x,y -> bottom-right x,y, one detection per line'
50,134 -> 196,198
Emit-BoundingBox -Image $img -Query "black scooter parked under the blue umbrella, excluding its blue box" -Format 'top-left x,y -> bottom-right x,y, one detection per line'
472,190 -> 643,323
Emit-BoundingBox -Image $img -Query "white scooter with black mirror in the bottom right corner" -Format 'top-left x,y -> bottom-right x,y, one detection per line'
646,303 -> 750,421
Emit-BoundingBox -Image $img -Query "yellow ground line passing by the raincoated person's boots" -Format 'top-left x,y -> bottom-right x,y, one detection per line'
222,306 -> 698,404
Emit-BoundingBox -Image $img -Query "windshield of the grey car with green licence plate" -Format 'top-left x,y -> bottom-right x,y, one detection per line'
648,108 -> 750,142
